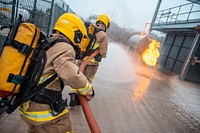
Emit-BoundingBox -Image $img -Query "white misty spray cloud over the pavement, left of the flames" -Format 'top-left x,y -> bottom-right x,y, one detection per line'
96,43 -> 140,83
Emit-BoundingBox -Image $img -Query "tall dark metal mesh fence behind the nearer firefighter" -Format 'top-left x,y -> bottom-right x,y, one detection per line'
0,0 -> 73,53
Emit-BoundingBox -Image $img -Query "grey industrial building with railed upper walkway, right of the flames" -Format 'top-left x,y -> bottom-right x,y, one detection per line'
150,0 -> 200,83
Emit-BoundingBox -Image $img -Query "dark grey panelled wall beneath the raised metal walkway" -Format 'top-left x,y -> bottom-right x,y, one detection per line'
159,33 -> 200,82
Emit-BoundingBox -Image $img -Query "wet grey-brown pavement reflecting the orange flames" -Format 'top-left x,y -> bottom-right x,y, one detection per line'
0,44 -> 200,133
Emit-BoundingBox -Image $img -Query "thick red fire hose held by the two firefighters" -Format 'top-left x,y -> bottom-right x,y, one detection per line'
79,50 -> 101,133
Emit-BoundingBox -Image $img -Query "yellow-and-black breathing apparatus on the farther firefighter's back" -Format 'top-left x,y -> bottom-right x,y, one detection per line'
81,22 -> 103,61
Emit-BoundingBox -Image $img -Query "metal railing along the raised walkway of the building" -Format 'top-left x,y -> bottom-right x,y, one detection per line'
154,3 -> 200,25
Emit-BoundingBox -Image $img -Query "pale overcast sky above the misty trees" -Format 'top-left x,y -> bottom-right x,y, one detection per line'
65,0 -> 188,31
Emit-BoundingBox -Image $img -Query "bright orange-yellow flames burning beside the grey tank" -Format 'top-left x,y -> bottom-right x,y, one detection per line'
142,38 -> 160,66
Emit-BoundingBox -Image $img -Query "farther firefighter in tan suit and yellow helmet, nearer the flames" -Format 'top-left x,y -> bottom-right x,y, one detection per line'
69,14 -> 110,106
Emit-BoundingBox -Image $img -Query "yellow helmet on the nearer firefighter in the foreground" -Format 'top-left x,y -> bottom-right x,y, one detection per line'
53,13 -> 87,46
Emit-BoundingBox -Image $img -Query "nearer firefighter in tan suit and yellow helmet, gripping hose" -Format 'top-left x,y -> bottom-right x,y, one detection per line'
20,13 -> 94,133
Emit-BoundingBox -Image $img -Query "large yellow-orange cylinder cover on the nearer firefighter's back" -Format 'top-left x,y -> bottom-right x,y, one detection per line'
0,20 -> 40,98
